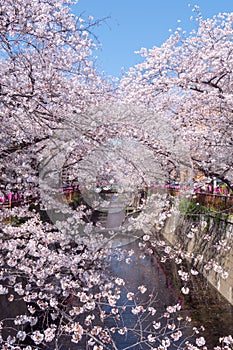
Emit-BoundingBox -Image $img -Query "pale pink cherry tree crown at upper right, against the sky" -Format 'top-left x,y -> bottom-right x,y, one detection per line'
120,13 -> 233,186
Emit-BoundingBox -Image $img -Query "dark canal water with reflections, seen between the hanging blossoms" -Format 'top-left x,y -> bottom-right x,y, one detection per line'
0,237 -> 233,350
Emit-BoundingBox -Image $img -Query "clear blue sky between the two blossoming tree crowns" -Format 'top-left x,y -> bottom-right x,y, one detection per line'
73,0 -> 233,77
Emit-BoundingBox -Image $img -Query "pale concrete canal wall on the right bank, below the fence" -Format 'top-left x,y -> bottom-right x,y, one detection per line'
163,212 -> 233,305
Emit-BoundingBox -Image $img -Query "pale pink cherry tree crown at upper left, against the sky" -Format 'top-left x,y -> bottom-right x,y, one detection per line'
0,0 -> 111,197
